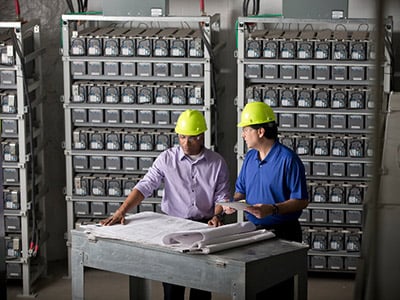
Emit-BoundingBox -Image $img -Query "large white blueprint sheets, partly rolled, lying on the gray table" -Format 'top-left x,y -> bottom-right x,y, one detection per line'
83,212 -> 275,254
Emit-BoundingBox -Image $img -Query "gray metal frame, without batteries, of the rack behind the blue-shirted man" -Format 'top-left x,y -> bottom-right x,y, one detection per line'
236,17 -> 392,272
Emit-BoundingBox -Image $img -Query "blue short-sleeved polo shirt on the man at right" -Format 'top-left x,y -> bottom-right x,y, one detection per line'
235,141 -> 308,225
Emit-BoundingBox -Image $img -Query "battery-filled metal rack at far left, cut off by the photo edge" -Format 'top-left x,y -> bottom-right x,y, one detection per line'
0,20 -> 47,296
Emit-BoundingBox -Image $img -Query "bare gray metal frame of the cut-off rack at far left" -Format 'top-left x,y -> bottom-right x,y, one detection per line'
0,20 -> 47,297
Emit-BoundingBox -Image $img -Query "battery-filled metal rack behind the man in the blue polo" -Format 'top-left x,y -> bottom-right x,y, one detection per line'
237,18 -> 391,272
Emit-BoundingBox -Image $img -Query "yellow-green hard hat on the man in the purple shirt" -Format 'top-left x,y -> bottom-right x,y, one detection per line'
175,109 -> 207,136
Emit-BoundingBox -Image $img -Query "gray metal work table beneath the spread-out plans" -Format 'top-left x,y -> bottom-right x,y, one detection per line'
71,230 -> 308,300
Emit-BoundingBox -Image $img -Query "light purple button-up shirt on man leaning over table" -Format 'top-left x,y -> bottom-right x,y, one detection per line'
135,147 -> 230,220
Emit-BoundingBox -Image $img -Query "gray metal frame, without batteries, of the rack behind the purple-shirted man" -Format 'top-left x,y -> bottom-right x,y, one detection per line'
61,14 -> 220,276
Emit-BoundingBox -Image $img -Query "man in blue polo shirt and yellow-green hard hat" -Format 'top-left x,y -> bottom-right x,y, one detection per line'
228,102 -> 308,299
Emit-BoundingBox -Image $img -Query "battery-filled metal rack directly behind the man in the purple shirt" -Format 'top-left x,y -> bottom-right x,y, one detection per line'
62,15 -> 220,274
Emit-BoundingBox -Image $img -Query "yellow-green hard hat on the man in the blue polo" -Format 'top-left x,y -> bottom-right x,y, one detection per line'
237,102 -> 276,127
